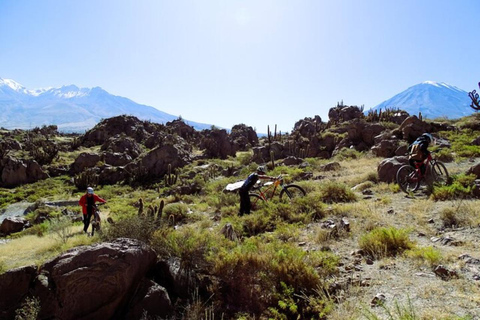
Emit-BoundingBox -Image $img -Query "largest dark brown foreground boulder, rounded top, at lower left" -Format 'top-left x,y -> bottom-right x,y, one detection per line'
37,239 -> 156,320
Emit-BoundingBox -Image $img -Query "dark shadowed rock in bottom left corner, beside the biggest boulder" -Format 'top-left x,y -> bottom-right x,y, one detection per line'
0,266 -> 37,319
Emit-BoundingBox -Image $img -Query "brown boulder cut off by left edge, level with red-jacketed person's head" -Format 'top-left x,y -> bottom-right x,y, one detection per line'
0,157 -> 49,187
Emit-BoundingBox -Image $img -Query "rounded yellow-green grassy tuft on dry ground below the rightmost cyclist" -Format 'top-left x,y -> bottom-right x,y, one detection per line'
359,227 -> 413,258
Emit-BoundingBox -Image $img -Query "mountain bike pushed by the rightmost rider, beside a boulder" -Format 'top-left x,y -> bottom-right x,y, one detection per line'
396,153 -> 449,193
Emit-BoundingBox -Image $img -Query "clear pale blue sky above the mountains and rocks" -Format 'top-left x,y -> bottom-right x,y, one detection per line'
0,0 -> 480,132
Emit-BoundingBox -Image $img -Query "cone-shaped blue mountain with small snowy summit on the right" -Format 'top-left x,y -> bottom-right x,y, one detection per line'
367,81 -> 475,119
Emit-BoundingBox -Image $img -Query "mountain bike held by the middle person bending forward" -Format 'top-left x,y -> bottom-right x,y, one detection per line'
248,175 -> 307,211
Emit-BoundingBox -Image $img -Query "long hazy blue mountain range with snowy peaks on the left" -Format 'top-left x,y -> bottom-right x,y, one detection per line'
0,78 -> 211,132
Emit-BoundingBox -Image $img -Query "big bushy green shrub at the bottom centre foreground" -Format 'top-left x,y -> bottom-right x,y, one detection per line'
210,237 -> 338,319
